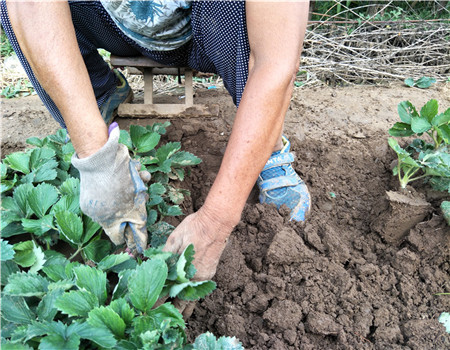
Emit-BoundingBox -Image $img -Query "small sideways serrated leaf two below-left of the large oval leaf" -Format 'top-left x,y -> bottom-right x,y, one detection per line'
55,289 -> 99,317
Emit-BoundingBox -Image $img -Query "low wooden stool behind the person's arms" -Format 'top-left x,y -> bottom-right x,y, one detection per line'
111,55 -> 219,118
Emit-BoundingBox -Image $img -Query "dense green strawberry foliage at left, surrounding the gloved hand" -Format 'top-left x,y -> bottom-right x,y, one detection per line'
0,123 -> 246,349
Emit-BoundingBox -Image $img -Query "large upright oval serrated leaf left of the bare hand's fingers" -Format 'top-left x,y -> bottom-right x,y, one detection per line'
128,259 -> 168,312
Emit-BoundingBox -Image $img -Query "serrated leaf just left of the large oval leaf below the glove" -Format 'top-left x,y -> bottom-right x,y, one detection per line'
73,265 -> 107,305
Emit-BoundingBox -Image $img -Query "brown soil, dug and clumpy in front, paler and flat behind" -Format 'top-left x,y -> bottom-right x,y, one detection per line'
2,81 -> 450,349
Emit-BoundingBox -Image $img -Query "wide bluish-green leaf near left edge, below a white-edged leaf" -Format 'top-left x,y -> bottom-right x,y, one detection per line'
4,272 -> 49,297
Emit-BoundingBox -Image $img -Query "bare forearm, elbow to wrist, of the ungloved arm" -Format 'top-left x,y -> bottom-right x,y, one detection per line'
203,65 -> 292,230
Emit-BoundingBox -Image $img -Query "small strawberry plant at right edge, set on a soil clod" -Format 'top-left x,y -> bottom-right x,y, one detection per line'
388,100 -> 450,192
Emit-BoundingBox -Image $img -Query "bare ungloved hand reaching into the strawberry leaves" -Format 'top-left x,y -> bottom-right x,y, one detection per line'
163,208 -> 233,319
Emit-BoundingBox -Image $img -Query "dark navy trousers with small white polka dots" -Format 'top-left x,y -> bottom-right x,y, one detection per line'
0,0 -> 250,127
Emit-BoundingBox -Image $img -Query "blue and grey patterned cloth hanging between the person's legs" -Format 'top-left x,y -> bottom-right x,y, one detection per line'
101,0 -> 192,51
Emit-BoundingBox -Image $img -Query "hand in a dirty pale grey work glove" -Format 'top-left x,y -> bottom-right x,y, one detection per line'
72,123 -> 150,253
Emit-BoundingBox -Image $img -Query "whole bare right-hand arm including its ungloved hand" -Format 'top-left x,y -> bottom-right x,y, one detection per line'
165,1 -> 309,280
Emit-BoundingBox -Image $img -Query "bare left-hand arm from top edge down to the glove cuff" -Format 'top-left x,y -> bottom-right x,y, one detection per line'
7,1 -> 108,158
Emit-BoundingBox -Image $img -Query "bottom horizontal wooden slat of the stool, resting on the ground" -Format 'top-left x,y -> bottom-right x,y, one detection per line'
118,103 -> 219,118
